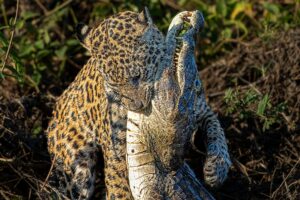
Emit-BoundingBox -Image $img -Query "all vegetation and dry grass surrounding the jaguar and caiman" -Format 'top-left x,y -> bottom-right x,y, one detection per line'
0,0 -> 300,199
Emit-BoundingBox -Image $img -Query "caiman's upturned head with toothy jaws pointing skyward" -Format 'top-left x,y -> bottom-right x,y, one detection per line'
152,11 -> 204,123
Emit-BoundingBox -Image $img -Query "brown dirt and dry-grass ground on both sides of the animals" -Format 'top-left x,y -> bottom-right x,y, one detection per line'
0,25 -> 300,199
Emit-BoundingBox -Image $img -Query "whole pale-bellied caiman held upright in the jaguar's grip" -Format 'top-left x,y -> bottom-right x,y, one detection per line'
126,11 -> 217,200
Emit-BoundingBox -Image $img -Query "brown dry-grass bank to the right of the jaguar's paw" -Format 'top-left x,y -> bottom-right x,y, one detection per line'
200,29 -> 300,199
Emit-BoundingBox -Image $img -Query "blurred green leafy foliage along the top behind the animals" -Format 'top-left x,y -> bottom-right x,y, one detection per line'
0,0 -> 300,91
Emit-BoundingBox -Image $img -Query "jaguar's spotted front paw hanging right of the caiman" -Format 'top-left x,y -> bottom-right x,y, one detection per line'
204,150 -> 231,187
